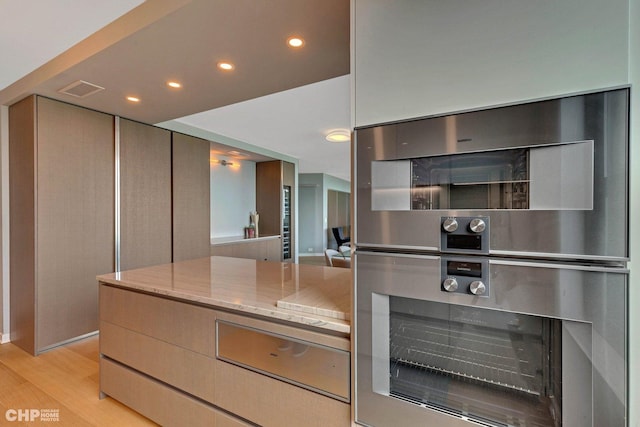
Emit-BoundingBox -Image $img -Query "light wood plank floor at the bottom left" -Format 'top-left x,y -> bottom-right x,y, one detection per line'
0,335 -> 156,427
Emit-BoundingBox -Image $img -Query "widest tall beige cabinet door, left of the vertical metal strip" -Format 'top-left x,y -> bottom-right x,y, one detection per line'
36,97 -> 114,349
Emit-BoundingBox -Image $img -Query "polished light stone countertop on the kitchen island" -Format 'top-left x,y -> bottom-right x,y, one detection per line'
98,256 -> 351,335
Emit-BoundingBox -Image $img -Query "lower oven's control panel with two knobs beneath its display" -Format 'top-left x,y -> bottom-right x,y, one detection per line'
440,257 -> 489,297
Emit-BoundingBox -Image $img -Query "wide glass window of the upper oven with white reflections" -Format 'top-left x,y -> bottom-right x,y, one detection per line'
371,141 -> 594,211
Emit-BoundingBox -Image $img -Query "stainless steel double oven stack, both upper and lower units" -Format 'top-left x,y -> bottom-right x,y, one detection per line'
352,88 -> 630,427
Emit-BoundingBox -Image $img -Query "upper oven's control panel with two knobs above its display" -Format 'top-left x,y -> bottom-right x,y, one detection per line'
440,216 -> 489,254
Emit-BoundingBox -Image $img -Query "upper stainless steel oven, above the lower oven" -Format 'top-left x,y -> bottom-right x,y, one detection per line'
354,88 -> 629,261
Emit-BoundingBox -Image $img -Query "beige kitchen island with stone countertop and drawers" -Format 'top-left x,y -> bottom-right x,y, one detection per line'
98,256 -> 351,426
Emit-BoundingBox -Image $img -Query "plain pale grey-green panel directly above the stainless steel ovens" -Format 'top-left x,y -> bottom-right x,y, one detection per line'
352,0 -> 629,126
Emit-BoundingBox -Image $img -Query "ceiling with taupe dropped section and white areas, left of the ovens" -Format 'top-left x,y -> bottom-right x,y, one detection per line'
0,0 -> 350,180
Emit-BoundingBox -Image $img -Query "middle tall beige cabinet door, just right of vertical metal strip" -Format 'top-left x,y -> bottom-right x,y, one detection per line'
120,119 -> 172,270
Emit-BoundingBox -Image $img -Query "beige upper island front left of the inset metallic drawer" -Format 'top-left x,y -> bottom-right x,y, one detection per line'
100,285 -> 216,357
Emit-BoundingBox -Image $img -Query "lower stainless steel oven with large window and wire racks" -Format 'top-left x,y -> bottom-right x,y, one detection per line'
354,250 -> 628,427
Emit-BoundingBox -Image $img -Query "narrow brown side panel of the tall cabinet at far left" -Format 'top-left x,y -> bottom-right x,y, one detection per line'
9,96 -> 36,353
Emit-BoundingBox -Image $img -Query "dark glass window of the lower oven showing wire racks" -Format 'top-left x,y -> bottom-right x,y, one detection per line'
390,297 -> 562,427
